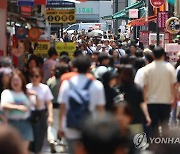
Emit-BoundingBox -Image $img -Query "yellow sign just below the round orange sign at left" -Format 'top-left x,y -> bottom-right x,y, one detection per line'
34,41 -> 50,58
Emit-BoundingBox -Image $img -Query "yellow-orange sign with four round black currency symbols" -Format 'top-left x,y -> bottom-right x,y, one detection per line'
46,9 -> 76,24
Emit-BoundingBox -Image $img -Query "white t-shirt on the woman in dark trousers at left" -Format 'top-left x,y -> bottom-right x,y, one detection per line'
26,83 -> 54,110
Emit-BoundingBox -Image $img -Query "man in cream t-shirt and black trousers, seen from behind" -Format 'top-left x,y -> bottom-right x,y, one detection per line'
144,46 -> 176,133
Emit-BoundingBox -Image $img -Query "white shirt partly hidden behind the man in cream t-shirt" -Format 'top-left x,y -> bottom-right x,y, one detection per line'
134,67 -> 145,88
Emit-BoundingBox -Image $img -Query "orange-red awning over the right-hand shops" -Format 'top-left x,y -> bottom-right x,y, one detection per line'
128,16 -> 157,26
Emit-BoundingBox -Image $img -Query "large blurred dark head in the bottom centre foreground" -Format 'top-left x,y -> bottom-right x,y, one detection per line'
82,114 -> 124,154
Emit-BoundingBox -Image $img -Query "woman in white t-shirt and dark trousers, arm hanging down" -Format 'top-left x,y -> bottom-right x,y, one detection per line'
26,68 -> 54,153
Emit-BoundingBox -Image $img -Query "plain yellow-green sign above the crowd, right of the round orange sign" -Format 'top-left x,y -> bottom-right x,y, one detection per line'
55,42 -> 76,59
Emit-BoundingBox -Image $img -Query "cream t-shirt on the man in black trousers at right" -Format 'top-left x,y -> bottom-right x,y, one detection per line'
144,60 -> 176,104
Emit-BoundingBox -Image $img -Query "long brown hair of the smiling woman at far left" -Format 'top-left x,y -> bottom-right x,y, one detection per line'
8,69 -> 27,94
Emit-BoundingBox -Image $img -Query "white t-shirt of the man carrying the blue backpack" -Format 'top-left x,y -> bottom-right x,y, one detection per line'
58,74 -> 105,139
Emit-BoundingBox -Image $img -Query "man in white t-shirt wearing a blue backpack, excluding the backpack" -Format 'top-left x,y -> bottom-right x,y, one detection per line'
58,56 -> 105,154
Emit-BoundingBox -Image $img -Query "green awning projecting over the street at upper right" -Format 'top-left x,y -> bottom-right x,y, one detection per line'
112,0 -> 145,19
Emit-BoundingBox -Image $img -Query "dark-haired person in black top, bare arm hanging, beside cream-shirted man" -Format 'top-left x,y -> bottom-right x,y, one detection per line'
119,65 -> 151,134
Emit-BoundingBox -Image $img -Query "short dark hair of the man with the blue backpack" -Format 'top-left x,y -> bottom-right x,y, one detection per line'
73,55 -> 91,73
